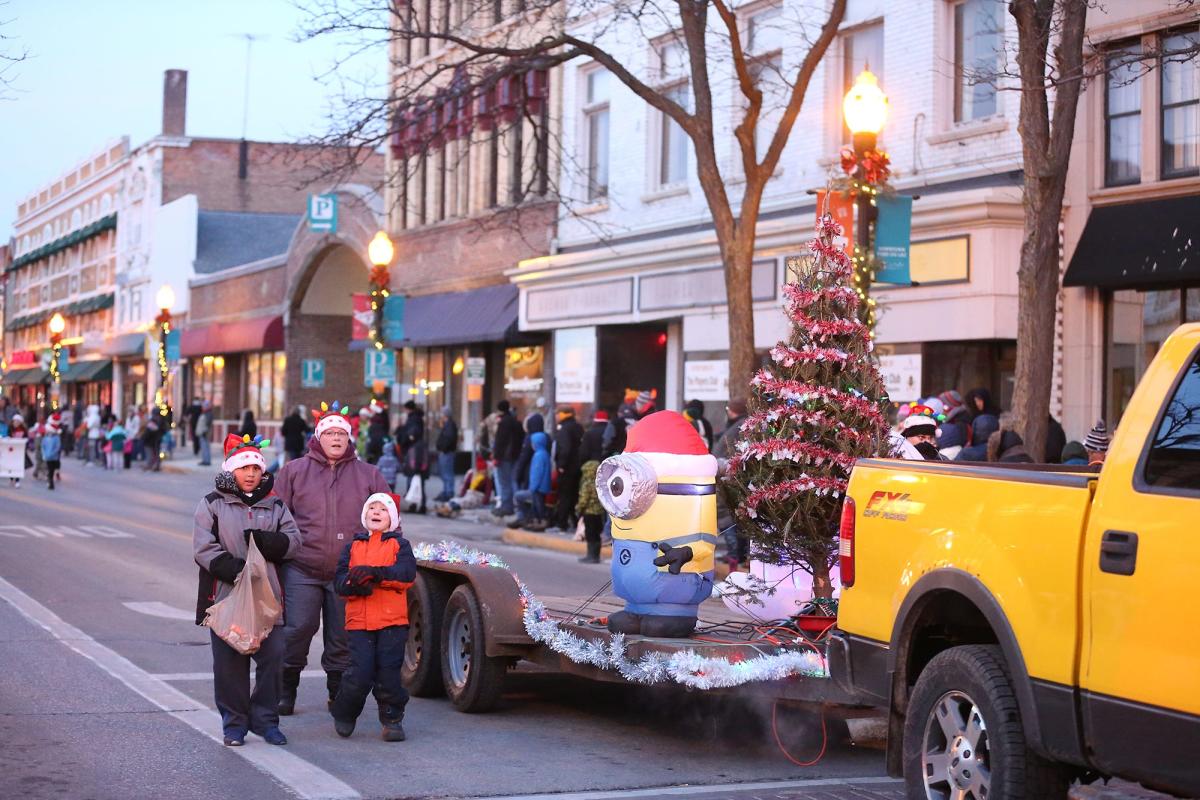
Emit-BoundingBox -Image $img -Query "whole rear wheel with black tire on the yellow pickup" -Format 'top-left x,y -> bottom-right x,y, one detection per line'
904,645 -> 1068,800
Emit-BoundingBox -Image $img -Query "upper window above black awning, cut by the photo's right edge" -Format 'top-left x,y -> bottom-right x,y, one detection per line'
1159,29 -> 1200,178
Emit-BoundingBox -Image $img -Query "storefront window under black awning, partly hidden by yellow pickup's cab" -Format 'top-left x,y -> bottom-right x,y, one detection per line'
1105,289 -> 1190,426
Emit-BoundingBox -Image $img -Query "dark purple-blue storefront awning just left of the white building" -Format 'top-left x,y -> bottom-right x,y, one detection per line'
389,283 -> 517,347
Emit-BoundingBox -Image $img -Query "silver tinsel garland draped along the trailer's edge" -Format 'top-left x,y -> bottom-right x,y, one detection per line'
413,541 -> 829,688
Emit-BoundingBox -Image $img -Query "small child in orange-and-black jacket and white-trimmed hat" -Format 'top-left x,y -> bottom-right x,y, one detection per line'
330,492 -> 416,741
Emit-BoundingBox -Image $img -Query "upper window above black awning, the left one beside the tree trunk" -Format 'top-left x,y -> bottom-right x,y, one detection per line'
1104,44 -> 1145,186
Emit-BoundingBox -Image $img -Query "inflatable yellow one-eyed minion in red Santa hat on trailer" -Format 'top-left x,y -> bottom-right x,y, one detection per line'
596,411 -> 716,637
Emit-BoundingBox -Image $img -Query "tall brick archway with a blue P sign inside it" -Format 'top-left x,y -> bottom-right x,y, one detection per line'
286,188 -> 379,417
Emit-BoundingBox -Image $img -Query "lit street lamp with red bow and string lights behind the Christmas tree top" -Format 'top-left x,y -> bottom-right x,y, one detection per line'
841,70 -> 888,335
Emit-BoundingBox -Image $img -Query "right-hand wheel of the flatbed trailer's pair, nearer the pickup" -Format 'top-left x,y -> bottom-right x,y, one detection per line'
442,584 -> 508,714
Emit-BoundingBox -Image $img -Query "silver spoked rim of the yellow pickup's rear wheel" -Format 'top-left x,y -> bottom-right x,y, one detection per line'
920,691 -> 991,800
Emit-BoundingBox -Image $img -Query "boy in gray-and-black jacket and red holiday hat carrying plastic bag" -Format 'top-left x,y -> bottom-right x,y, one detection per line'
192,434 -> 300,747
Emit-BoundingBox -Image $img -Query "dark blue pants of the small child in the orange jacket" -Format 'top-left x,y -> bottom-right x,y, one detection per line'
329,625 -> 408,724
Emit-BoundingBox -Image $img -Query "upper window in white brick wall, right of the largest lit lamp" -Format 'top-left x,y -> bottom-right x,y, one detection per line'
954,0 -> 1004,122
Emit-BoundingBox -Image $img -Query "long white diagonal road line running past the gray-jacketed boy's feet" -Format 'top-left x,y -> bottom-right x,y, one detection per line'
0,578 -> 361,800
